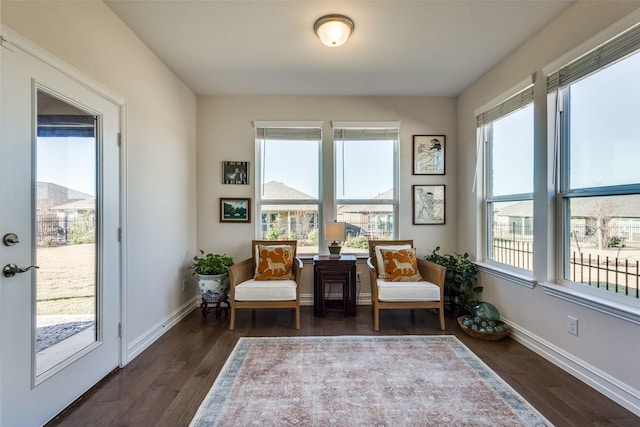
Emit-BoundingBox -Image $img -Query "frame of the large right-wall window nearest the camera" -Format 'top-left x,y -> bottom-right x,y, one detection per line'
541,19 -> 640,310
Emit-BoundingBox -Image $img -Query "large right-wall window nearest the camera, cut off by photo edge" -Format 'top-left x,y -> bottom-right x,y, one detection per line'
547,28 -> 640,299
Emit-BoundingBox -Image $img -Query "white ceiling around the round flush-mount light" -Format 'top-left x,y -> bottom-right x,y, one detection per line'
105,0 -> 574,96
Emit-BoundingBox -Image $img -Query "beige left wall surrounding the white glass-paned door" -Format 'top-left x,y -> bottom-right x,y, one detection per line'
2,0 -> 197,362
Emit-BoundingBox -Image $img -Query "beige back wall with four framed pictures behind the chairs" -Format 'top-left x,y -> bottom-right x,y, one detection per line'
197,96 -> 457,301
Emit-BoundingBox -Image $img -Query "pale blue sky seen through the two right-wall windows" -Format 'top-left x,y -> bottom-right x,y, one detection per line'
493,50 -> 640,199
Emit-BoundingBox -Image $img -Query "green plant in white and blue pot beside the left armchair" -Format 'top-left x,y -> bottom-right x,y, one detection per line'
189,250 -> 233,303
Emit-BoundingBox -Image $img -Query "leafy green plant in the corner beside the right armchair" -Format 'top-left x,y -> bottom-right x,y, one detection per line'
425,246 -> 482,317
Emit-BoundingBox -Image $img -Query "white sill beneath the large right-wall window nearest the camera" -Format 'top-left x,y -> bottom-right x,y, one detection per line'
540,283 -> 640,325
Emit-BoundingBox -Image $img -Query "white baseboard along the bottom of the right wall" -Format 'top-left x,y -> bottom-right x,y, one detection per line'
503,319 -> 640,416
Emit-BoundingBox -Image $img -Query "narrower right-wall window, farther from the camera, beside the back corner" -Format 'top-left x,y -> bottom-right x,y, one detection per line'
477,86 -> 533,270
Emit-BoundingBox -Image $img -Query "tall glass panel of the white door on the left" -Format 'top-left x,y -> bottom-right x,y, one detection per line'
33,90 -> 97,375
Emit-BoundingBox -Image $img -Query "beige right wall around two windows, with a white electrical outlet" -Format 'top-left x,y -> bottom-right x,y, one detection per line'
456,2 -> 640,413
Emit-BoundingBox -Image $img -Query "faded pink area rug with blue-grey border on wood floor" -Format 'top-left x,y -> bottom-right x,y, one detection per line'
191,335 -> 551,427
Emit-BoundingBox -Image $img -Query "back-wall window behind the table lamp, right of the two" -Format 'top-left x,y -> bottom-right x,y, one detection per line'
333,122 -> 399,253
